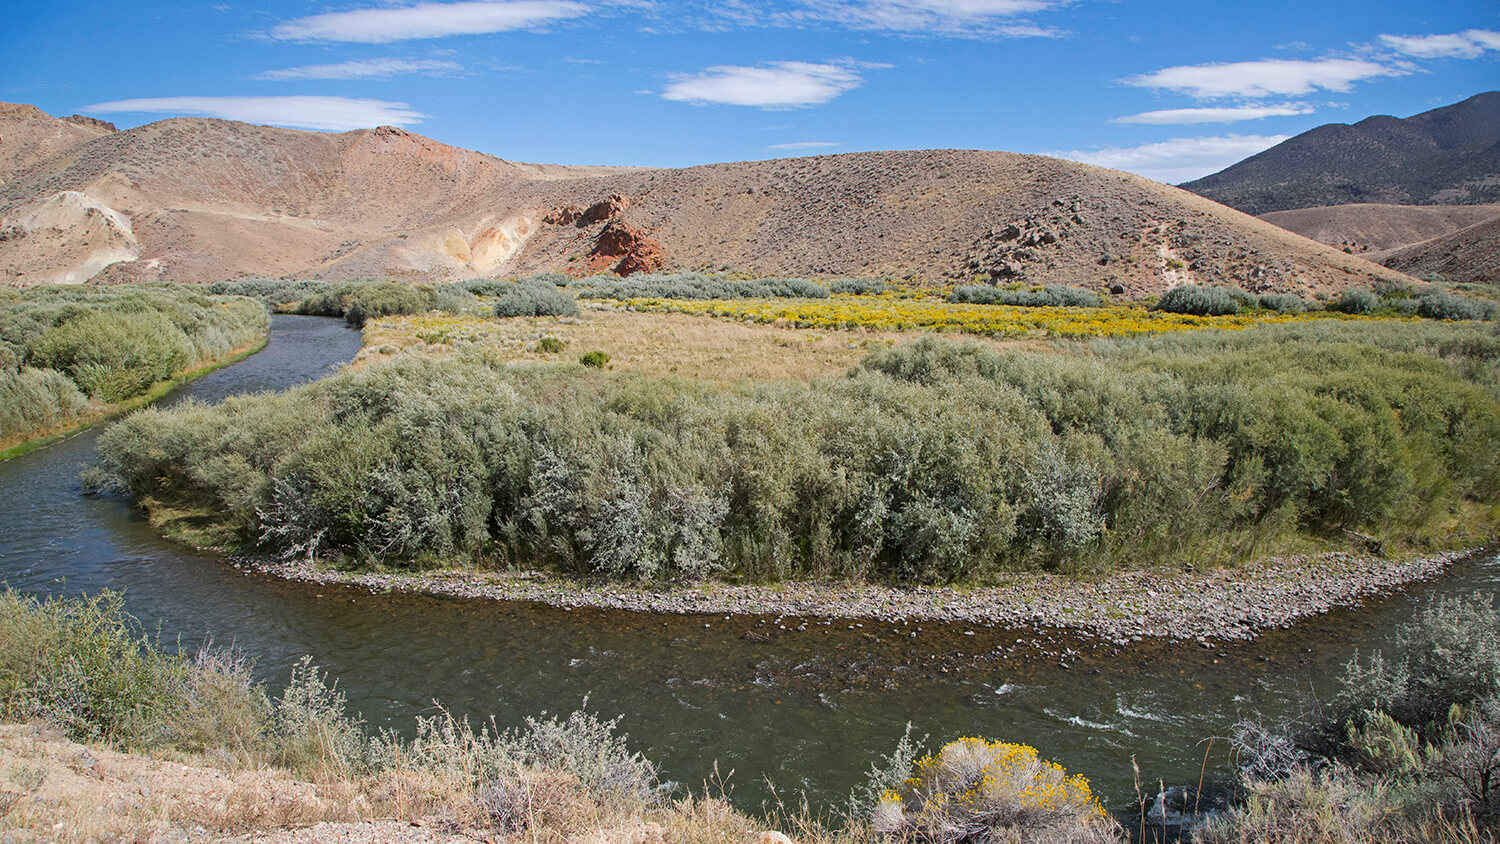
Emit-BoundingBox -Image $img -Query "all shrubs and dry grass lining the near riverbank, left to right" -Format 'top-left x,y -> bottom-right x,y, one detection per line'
0,592 -> 1500,844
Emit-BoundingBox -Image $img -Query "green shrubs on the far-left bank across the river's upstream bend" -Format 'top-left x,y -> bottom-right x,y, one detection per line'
0,285 -> 269,448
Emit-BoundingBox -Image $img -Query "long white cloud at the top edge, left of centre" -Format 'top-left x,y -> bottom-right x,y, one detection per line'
272,0 -> 588,43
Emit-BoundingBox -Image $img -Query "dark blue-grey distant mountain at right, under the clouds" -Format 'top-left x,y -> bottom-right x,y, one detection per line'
1182,91 -> 1500,214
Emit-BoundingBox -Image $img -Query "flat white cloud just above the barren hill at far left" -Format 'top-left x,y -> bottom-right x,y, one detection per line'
83,96 -> 428,132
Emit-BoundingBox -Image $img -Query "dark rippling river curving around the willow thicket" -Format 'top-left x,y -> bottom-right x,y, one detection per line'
0,315 -> 1500,810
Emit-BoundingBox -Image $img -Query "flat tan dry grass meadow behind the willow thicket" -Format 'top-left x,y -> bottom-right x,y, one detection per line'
356,304 -> 1037,382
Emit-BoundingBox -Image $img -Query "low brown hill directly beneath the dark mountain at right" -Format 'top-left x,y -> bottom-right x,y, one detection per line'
1260,202 -> 1500,253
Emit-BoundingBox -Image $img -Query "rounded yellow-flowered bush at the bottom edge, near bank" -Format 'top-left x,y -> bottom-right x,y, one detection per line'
872,738 -> 1115,844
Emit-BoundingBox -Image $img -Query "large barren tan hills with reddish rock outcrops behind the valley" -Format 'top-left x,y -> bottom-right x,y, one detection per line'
0,106 -> 1398,294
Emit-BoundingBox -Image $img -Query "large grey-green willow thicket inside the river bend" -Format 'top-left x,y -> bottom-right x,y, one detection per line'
95,322 -> 1500,582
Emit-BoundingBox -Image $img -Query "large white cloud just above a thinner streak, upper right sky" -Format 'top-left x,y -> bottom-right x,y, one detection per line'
1122,58 -> 1410,99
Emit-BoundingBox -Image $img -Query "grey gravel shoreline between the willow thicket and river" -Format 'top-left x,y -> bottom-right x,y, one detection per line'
233,549 -> 1482,645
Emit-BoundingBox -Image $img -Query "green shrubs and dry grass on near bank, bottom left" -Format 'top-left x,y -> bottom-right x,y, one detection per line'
0,591 -> 780,841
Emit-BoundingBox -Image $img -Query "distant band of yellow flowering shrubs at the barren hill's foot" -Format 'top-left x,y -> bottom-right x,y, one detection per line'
624,294 -> 1374,337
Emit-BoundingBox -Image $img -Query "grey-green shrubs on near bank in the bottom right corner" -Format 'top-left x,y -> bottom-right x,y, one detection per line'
1199,595 -> 1500,844
